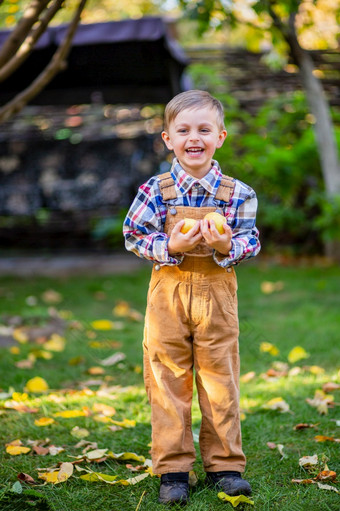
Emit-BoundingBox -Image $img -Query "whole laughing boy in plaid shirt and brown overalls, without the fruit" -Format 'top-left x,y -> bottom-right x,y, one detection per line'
123,90 -> 260,504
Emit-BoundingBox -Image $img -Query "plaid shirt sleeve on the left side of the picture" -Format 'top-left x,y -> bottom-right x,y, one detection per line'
123,177 -> 183,265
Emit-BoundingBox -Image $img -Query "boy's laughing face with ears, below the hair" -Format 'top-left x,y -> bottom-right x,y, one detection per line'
162,107 -> 227,179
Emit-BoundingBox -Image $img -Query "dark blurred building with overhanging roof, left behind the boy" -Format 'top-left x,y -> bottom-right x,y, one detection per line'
0,18 -> 190,249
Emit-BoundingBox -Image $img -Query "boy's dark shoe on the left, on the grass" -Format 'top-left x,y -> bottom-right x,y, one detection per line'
158,472 -> 189,505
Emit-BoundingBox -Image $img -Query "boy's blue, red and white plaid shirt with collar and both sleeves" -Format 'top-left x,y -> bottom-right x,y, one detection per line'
123,158 -> 260,268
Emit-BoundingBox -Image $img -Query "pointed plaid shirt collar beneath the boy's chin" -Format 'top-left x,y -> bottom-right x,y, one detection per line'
170,158 -> 222,195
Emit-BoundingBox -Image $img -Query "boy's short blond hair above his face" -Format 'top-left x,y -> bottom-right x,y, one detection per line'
164,89 -> 225,131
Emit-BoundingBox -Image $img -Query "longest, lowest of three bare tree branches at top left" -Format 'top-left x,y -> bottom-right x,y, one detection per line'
0,0 -> 87,123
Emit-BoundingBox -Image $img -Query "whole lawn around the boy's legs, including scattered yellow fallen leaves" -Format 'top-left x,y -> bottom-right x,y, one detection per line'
0,259 -> 340,511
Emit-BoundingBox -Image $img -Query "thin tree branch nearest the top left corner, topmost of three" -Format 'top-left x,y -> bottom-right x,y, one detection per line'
0,0 -> 50,68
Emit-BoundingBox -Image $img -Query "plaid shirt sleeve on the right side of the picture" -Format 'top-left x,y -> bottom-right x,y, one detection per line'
213,185 -> 261,268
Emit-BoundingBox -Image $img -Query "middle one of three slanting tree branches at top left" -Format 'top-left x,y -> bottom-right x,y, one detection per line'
0,0 -> 64,82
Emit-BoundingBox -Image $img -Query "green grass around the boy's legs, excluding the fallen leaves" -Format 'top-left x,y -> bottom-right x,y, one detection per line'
0,260 -> 340,511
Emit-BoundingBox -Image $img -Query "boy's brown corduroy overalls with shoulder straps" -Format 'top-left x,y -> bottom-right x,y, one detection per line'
143,173 -> 246,474
